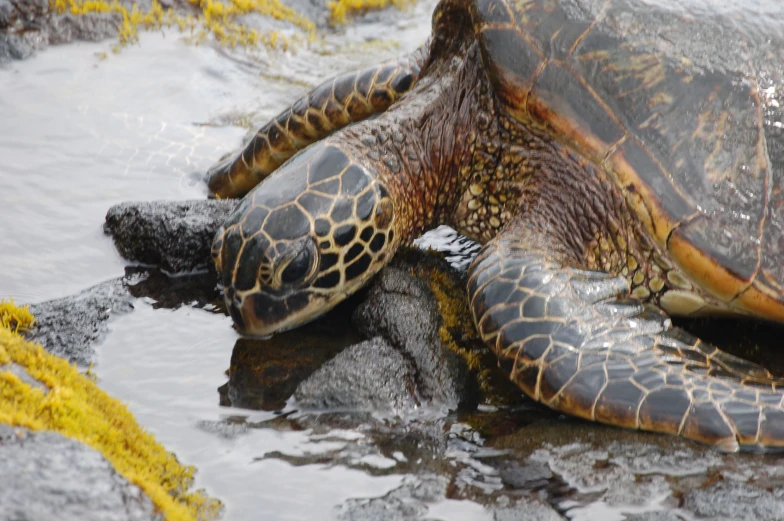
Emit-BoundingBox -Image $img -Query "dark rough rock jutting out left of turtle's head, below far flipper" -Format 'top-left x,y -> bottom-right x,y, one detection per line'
104,200 -> 237,273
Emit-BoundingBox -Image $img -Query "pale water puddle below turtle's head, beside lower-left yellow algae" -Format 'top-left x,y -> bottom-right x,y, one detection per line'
97,302 -> 401,520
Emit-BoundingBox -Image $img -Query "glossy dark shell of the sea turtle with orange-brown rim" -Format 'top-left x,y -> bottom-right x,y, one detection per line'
471,0 -> 784,320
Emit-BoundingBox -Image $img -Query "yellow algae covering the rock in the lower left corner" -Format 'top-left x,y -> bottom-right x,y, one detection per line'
0,302 -> 222,521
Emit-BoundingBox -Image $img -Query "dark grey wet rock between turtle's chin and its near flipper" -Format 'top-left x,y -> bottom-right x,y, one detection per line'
294,260 -> 476,413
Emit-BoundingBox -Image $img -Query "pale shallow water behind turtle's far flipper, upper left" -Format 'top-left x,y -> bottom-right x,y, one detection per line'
0,0 -> 435,302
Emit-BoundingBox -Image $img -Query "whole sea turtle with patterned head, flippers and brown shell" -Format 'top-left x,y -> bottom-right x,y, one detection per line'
209,0 -> 784,451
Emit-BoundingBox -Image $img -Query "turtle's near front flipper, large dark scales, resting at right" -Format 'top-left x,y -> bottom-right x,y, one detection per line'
468,221 -> 784,451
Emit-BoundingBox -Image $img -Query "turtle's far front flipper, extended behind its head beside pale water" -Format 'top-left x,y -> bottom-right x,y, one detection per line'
207,45 -> 427,198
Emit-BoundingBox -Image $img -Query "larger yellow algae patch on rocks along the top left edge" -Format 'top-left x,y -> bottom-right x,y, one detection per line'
49,0 -> 316,52
